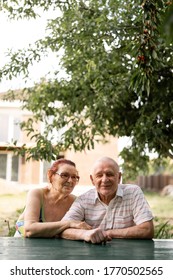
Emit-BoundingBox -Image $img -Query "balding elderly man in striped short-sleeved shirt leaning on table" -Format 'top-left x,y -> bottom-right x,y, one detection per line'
61,157 -> 154,243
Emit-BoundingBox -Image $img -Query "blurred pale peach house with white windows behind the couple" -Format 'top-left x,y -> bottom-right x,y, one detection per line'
0,96 -> 118,186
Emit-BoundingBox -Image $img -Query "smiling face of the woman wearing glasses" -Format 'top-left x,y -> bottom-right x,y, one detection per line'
52,164 -> 79,194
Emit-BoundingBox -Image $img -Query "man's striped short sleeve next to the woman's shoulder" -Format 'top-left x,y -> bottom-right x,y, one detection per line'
62,197 -> 85,221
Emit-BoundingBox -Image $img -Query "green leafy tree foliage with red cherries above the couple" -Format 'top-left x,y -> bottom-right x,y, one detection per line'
0,0 -> 173,180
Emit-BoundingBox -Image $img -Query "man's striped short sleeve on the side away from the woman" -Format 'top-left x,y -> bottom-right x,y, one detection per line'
133,187 -> 153,225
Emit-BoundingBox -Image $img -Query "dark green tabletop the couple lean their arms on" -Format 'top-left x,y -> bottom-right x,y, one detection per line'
0,237 -> 173,260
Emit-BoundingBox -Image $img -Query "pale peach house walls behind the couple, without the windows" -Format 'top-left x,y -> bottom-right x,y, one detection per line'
0,100 -> 118,186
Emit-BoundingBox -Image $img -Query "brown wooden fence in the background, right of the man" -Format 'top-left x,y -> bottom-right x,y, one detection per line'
136,174 -> 173,191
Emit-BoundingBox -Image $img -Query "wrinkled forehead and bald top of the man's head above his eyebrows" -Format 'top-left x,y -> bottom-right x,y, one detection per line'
91,159 -> 119,174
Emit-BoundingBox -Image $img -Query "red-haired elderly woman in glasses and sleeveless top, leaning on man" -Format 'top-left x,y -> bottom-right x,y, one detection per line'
14,159 -> 90,238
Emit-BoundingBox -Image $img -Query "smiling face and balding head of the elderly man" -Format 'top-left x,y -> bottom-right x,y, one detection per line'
90,160 -> 121,200
